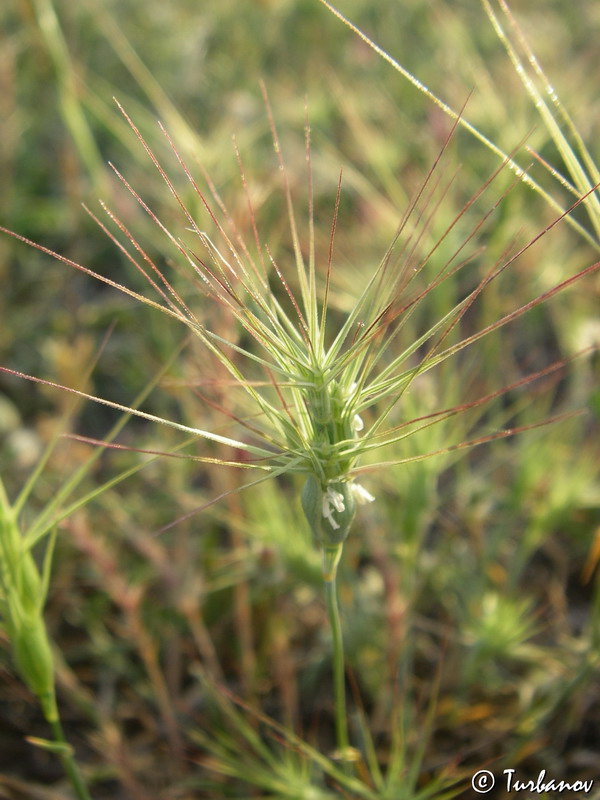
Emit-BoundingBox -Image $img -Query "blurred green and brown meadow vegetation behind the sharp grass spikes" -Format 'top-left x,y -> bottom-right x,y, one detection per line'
0,0 -> 600,800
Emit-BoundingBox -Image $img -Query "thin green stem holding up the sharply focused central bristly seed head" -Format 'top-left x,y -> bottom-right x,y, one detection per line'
323,543 -> 350,760
